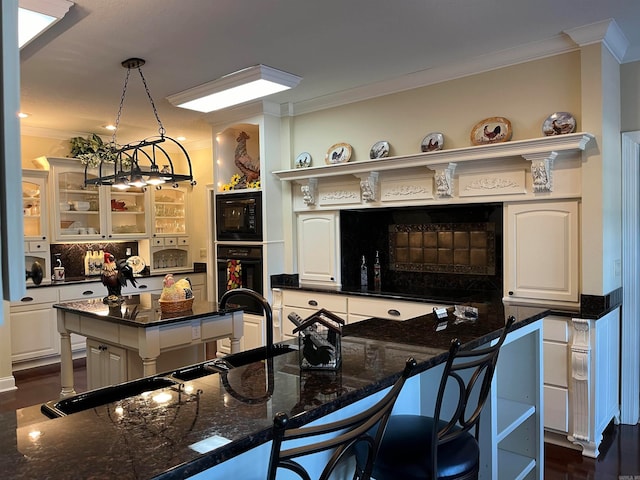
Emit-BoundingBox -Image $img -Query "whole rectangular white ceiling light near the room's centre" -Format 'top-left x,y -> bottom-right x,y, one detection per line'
167,65 -> 302,113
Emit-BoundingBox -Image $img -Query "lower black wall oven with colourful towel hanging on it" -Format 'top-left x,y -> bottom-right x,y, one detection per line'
217,245 -> 264,315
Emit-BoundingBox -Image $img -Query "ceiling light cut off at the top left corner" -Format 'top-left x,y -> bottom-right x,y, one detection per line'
18,0 -> 73,48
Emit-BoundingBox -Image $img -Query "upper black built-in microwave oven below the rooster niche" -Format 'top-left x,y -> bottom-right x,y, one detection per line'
215,191 -> 262,242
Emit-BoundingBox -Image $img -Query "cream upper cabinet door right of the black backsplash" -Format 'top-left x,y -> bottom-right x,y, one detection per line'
504,200 -> 580,306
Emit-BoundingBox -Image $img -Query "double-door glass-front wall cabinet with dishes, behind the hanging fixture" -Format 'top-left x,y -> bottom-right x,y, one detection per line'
49,158 -> 149,242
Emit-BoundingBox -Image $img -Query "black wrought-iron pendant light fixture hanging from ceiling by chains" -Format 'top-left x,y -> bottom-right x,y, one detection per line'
84,58 -> 196,190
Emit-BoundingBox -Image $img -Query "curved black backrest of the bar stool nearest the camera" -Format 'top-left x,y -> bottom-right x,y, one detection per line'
267,358 -> 416,480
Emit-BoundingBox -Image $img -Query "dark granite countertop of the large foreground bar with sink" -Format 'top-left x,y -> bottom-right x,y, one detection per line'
0,302 -> 548,480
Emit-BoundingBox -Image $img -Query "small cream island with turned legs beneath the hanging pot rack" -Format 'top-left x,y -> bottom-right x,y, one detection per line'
54,293 -> 243,398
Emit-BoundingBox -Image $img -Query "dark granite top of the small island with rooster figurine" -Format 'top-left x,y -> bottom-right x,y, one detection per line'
54,293 -> 240,327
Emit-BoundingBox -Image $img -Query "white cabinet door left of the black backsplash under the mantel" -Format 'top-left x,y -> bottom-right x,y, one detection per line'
297,212 -> 341,286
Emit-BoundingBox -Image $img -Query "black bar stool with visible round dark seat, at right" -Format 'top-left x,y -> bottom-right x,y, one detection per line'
358,317 -> 515,480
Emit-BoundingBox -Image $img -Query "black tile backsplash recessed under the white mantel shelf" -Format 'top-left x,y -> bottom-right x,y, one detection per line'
340,203 -> 503,295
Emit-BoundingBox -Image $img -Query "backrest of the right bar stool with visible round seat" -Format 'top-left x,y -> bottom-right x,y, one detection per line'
431,317 -> 515,466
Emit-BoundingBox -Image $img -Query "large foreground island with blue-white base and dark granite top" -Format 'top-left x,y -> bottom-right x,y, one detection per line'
0,303 -> 547,480
